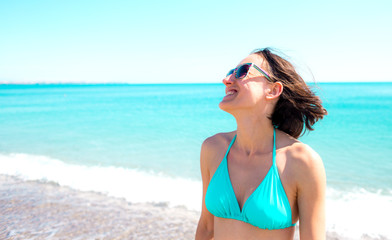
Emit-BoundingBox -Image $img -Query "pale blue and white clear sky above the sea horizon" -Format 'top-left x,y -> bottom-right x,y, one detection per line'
0,0 -> 392,83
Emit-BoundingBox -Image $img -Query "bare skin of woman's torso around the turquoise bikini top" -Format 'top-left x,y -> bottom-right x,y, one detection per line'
209,130 -> 299,239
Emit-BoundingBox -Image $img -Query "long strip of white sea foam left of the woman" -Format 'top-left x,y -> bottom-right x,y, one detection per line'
0,153 -> 202,210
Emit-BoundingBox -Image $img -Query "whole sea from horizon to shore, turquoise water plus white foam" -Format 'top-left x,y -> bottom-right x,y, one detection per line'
0,82 -> 392,239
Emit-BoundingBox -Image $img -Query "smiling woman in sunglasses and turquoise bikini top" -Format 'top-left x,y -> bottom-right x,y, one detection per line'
196,48 -> 327,240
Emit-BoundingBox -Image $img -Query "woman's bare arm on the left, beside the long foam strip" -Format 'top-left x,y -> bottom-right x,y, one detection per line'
196,137 -> 215,239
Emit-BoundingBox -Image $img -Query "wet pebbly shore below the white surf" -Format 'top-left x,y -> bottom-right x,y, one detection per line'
0,174 -> 386,240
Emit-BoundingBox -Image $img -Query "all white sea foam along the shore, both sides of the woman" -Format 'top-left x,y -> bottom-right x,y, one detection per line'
0,153 -> 392,239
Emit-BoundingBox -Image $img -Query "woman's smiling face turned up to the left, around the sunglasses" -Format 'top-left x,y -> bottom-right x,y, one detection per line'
219,54 -> 270,113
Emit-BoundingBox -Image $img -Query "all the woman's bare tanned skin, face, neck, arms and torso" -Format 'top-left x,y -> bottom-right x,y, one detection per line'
196,55 -> 326,240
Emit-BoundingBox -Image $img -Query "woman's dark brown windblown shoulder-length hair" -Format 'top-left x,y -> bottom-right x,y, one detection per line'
252,48 -> 327,138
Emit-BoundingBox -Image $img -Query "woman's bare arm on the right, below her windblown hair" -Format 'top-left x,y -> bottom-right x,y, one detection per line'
296,144 -> 326,240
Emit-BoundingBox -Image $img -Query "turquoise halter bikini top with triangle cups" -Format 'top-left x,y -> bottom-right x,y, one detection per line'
205,128 -> 295,230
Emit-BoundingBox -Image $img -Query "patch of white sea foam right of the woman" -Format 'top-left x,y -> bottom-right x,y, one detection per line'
326,188 -> 392,239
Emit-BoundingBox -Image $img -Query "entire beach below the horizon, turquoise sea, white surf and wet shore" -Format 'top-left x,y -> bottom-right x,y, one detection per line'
0,83 -> 392,240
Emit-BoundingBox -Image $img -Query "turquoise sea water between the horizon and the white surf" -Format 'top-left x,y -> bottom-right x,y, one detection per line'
0,83 -> 392,191
